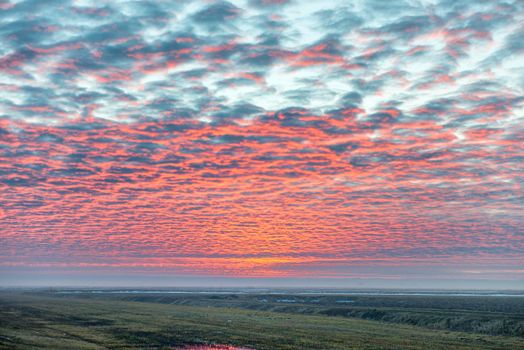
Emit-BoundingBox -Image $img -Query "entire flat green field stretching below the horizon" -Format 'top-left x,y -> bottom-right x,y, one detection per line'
0,291 -> 524,350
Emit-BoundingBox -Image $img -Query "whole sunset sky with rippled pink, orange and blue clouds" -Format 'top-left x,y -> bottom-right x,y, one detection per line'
0,0 -> 524,289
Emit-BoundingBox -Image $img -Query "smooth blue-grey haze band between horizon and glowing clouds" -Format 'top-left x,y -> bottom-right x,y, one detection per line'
0,267 -> 524,291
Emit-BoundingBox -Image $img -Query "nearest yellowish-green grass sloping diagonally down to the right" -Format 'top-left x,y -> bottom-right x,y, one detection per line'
0,293 -> 524,350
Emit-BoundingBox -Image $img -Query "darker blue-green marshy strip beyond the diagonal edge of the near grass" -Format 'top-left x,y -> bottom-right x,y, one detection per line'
78,292 -> 524,337
